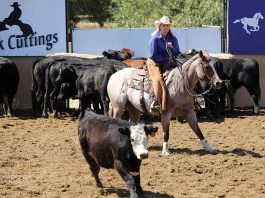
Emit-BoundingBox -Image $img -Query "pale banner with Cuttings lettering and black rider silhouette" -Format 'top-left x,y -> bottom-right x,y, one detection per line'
0,0 -> 67,56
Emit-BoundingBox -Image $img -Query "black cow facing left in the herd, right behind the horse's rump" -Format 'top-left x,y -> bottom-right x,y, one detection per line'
56,65 -> 116,119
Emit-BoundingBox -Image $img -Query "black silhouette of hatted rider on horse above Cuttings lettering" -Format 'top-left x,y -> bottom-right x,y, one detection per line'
0,2 -> 35,38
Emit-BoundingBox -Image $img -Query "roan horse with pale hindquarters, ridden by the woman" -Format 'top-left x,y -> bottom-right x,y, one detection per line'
107,51 -> 219,155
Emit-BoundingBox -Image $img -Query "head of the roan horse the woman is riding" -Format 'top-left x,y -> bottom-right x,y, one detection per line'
196,51 -> 222,89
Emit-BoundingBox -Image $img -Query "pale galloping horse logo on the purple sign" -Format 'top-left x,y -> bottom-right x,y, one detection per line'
233,12 -> 264,34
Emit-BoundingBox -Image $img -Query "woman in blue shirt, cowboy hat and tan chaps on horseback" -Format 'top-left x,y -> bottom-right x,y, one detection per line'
146,16 -> 180,112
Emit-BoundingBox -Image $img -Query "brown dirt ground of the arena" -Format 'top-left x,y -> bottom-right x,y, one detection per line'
0,109 -> 265,198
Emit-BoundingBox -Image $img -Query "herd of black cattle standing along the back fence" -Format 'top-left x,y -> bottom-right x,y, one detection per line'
0,50 -> 261,118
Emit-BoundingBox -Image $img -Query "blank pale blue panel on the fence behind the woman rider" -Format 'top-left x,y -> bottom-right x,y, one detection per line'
72,27 -> 221,58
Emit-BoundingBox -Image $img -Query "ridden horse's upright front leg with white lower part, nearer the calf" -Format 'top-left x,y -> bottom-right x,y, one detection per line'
161,113 -> 171,155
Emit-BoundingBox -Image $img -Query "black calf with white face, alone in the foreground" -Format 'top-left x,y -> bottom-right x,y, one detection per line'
78,112 -> 158,197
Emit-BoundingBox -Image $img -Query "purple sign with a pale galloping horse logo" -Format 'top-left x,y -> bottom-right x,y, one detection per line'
228,0 -> 265,54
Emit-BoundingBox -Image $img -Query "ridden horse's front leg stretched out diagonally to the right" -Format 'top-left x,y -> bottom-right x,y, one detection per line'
186,111 -> 214,153
